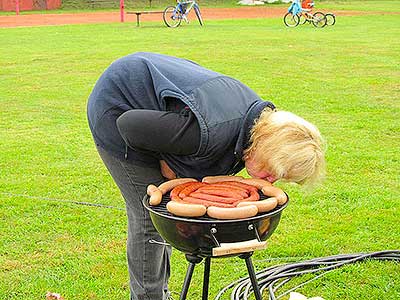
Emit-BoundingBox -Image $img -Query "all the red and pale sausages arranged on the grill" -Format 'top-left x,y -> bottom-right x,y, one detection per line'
147,176 -> 287,219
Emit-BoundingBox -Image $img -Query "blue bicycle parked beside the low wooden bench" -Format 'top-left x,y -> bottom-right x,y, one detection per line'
163,0 -> 203,27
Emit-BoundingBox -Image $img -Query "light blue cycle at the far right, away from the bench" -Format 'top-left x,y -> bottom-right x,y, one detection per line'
283,0 -> 327,28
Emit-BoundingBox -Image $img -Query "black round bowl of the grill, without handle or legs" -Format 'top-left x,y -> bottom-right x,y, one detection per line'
143,193 -> 288,257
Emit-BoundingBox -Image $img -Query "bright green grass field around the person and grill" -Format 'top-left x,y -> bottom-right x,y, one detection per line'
0,1 -> 400,300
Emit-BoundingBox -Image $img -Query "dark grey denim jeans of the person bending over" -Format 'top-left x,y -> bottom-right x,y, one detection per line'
97,147 -> 171,300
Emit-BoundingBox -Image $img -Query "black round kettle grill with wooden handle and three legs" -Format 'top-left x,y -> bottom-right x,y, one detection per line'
143,193 -> 288,300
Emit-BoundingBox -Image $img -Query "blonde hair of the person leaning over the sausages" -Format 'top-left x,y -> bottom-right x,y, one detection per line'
244,109 -> 325,186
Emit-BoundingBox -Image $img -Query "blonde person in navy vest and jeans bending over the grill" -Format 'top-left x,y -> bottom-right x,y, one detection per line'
88,53 -> 324,300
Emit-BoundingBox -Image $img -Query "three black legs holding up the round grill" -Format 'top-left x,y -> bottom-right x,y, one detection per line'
179,252 -> 262,300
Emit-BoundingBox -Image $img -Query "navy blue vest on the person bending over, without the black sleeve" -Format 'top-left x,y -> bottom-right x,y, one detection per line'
88,52 -> 274,178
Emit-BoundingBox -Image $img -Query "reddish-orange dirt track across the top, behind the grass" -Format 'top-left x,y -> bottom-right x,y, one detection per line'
0,6 -> 390,27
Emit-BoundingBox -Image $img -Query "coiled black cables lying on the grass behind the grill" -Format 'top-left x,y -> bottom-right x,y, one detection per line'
214,250 -> 400,300
